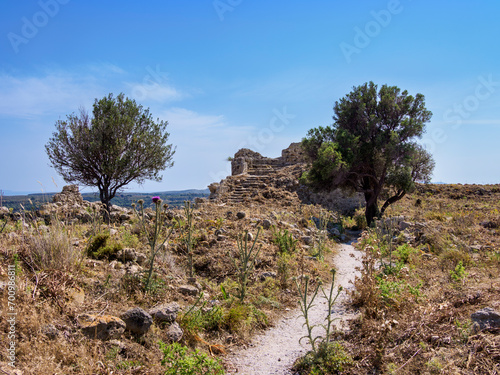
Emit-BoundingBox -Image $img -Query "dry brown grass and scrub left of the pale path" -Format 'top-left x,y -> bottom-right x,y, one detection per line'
0,200 -> 334,374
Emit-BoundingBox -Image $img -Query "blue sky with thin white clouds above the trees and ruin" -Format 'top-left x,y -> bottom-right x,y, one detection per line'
0,0 -> 500,191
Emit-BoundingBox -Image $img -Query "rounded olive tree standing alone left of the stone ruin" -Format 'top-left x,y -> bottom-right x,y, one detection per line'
45,94 -> 175,212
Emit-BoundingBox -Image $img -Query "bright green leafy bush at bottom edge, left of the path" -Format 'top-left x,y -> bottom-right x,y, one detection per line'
159,341 -> 225,375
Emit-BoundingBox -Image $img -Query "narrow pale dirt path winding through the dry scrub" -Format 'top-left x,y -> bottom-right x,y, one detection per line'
228,244 -> 361,375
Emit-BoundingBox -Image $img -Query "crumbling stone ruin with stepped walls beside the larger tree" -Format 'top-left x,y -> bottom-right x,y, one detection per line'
208,143 -> 364,213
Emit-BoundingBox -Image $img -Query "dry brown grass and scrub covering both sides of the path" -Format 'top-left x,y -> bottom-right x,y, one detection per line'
0,185 -> 500,374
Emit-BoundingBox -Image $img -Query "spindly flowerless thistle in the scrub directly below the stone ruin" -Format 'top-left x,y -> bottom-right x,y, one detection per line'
229,227 -> 262,303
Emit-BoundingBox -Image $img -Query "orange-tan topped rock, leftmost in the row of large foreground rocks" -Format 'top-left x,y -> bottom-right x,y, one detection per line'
77,314 -> 126,341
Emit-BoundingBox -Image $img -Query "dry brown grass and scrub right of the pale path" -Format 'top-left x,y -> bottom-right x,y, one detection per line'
337,185 -> 500,374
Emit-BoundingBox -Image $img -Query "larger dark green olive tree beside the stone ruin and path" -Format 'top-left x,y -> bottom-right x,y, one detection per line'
302,82 -> 434,224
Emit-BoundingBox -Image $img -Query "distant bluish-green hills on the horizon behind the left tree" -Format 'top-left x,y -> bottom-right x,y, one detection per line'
0,189 -> 210,211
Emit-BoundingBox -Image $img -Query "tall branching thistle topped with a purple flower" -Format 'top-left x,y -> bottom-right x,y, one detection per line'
132,197 -> 174,291
